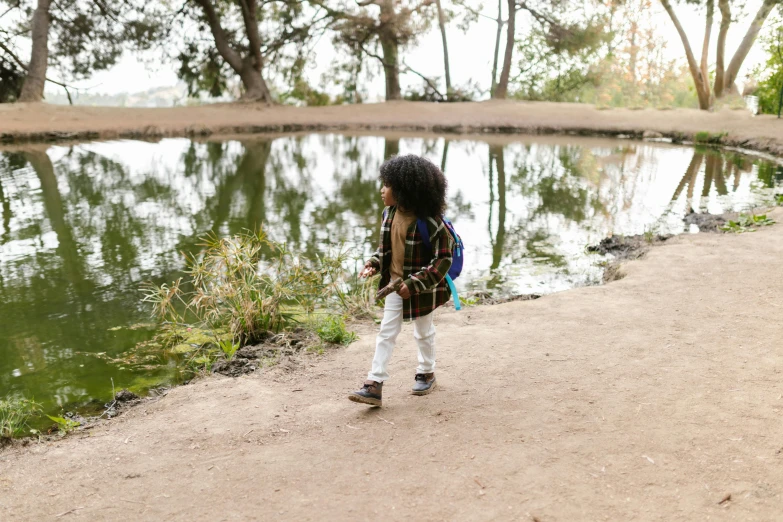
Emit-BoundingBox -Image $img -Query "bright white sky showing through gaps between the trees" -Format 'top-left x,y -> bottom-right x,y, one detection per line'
30,0 -> 764,101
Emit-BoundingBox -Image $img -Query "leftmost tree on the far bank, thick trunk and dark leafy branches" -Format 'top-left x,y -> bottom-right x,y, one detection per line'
0,0 -> 160,102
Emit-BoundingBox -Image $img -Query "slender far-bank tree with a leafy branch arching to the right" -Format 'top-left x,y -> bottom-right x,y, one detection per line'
492,0 -> 604,99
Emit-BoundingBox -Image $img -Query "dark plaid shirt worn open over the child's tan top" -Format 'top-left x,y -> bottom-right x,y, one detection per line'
369,206 -> 454,321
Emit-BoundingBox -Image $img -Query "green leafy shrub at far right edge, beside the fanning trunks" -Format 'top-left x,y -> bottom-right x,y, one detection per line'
752,7 -> 783,114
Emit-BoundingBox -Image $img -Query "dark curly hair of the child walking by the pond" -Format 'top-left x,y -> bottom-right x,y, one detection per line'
378,154 -> 448,219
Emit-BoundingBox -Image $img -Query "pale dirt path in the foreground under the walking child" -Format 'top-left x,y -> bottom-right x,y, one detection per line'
0,212 -> 783,522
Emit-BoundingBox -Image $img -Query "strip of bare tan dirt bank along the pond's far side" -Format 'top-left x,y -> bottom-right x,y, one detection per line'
0,101 -> 783,155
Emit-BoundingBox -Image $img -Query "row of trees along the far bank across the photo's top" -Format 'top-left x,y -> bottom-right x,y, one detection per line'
0,0 -> 783,110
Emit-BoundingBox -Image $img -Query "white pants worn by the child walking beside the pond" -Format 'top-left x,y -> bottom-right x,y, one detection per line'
367,294 -> 435,382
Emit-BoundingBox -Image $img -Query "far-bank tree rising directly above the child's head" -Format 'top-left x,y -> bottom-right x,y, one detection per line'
336,0 -> 443,101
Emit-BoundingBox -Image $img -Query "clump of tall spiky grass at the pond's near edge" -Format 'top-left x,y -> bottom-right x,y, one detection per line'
144,230 -> 374,346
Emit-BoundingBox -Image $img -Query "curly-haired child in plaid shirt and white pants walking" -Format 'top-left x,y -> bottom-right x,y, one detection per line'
348,155 -> 454,406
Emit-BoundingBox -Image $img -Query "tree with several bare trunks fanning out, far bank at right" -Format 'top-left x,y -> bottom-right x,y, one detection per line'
661,0 -> 780,110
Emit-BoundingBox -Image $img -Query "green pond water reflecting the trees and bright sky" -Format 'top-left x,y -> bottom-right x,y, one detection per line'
0,135 -> 783,412
